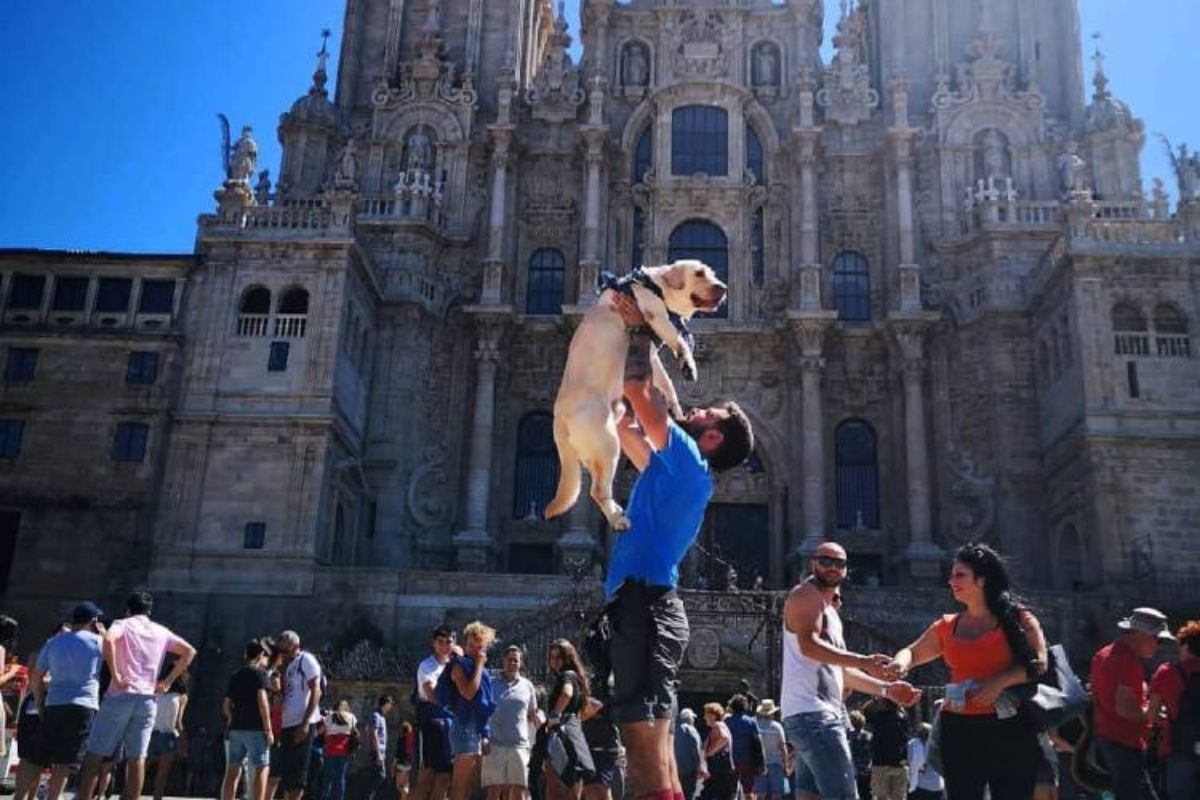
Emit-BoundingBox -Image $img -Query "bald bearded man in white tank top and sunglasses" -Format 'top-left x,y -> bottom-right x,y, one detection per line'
780,542 -> 920,800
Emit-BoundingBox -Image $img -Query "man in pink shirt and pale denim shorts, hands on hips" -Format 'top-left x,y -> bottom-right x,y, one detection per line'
79,591 -> 196,800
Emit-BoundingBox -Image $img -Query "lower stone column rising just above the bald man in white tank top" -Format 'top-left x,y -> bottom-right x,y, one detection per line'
790,312 -> 836,557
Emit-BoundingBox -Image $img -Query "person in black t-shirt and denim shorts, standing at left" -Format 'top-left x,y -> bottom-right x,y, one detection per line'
221,639 -> 275,800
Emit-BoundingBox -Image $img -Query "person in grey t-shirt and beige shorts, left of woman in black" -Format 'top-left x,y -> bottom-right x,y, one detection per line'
481,644 -> 538,800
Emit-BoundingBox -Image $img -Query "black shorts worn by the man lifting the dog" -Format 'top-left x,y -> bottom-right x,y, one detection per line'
607,581 -> 690,724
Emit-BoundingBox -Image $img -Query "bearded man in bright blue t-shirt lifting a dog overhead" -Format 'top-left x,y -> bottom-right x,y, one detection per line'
605,295 -> 754,800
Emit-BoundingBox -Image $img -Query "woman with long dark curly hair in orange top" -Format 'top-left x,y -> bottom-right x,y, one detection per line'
890,545 -> 1046,800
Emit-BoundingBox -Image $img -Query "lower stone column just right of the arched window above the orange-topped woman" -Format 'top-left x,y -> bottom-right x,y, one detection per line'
893,320 -> 943,583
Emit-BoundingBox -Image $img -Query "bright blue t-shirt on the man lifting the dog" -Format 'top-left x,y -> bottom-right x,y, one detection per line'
604,422 -> 713,600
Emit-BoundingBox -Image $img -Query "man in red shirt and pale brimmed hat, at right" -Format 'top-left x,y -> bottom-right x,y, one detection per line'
1091,608 -> 1175,800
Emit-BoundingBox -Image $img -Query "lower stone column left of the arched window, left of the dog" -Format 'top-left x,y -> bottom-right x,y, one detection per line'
454,316 -> 505,572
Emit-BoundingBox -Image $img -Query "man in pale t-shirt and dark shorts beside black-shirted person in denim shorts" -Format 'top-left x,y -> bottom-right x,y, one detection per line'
276,631 -> 324,800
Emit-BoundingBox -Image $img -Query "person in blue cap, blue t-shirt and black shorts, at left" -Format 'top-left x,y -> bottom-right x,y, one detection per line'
13,602 -> 104,800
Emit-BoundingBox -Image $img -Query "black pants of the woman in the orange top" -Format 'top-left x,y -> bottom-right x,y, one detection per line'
941,711 -> 1042,800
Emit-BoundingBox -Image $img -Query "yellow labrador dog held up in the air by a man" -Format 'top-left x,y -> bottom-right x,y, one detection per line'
545,260 -> 726,530
